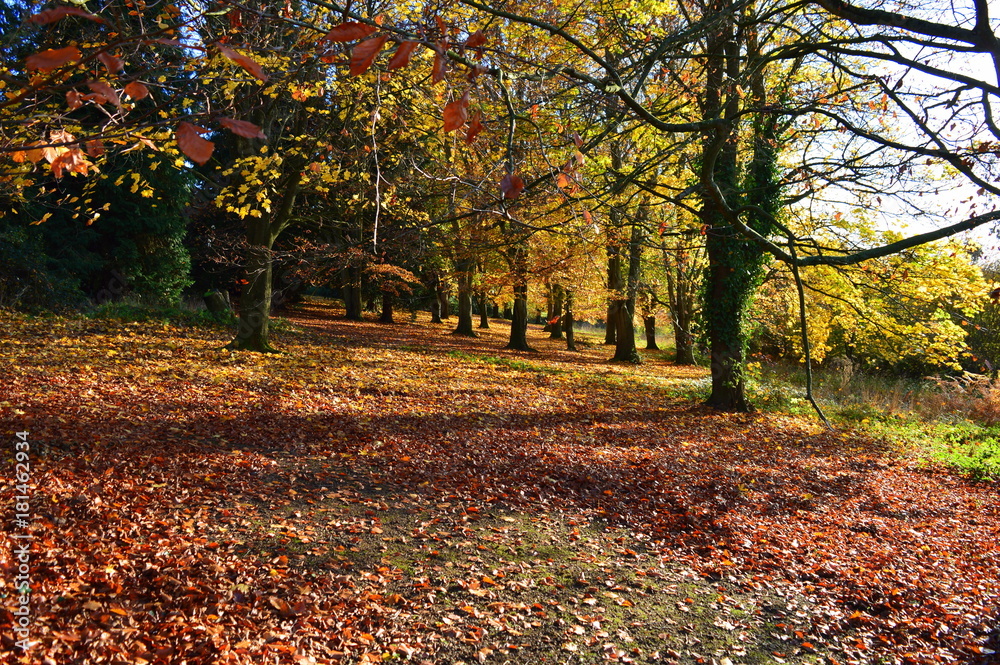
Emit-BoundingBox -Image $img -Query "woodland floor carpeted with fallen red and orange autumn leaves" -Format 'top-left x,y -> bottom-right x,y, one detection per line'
0,301 -> 1000,665
